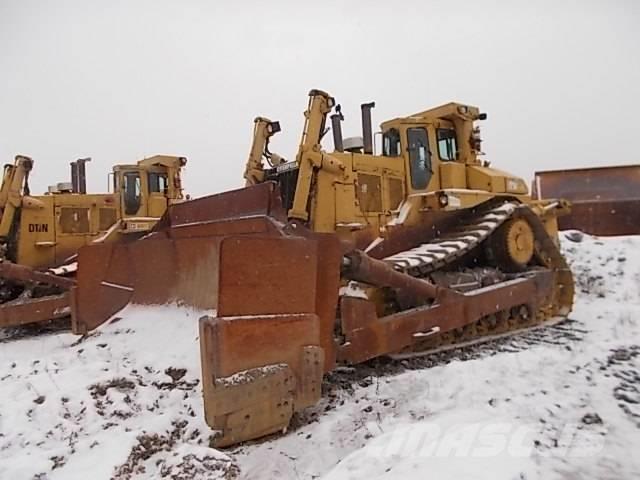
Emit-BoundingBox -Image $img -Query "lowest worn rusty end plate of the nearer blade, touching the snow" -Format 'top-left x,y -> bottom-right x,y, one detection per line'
200,314 -> 324,446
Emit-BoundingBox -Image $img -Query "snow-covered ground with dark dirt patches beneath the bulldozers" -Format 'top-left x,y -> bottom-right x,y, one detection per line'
0,232 -> 640,480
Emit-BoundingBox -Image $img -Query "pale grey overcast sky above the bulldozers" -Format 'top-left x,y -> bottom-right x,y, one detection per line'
0,0 -> 640,196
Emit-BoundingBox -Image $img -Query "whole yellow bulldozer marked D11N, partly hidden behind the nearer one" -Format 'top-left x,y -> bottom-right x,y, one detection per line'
0,155 -> 186,327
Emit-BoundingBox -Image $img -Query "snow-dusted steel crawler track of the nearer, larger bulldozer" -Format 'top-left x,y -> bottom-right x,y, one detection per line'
384,197 -> 573,358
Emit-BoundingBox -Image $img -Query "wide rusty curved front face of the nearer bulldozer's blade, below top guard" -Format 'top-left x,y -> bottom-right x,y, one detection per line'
72,237 -> 220,333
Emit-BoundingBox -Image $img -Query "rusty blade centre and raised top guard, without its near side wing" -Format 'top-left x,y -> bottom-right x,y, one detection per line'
71,183 -> 286,334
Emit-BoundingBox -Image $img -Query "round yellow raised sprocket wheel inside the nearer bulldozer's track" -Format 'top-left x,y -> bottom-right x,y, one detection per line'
487,218 -> 535,272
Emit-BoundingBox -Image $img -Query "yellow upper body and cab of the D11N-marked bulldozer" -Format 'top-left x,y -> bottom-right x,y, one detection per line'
0,155 -> 186,268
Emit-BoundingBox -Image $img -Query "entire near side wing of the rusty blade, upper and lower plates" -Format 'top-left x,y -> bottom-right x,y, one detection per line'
200,230 -> 341,446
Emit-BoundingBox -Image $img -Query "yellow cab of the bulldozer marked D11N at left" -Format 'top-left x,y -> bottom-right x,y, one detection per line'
113,155 -> 186,219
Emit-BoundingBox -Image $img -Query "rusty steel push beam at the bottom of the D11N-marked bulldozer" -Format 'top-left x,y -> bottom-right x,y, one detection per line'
0,292 -> 71,327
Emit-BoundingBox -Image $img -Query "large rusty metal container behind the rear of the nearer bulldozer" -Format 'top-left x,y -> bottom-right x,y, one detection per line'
532,165 -> 640,235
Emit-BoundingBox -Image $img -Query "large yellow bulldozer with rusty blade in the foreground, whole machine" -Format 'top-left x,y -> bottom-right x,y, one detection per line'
73,90 -> 573,446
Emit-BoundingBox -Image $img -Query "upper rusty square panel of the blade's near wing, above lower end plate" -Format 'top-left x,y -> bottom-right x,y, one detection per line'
218,234 -> 342,371
